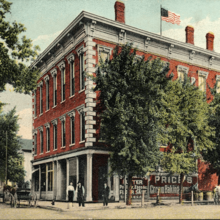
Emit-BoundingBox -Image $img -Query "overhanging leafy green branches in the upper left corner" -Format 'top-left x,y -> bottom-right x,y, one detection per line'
0,0 -> 39,94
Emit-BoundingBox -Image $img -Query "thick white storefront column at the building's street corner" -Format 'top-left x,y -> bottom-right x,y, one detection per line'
86,154 -> 92,202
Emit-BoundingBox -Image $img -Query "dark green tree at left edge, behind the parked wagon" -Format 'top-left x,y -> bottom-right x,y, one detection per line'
0,108 -> 25,182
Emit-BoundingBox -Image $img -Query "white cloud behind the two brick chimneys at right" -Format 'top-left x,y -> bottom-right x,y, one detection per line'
163,16 -> 220,53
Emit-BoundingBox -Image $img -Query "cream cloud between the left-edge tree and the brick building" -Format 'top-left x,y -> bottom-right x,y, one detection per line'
16,108 -> 32,139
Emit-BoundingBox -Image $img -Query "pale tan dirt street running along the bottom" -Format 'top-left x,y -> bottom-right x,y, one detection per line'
0,203 -> 220,219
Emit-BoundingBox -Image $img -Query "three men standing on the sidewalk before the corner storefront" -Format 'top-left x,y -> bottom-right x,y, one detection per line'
66,182 -> 109,209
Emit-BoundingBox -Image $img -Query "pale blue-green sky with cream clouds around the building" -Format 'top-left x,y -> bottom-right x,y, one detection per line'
0,0 -> 220,139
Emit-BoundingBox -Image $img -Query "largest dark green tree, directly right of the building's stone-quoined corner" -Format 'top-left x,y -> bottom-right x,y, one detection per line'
94,44 -> 170,205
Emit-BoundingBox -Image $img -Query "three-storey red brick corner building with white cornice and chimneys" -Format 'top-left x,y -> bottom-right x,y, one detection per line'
31,1 -> 220,202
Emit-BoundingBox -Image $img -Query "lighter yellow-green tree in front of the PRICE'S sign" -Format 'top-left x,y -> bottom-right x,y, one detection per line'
161,76 -> 214,203
